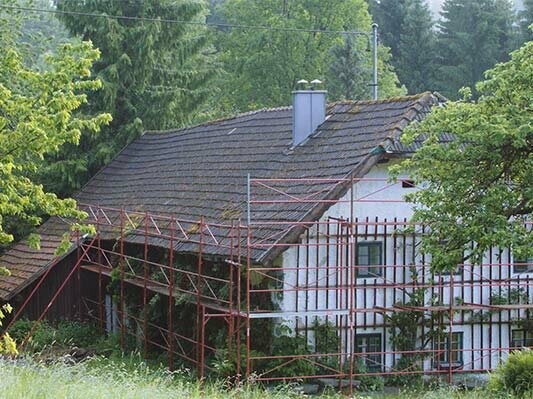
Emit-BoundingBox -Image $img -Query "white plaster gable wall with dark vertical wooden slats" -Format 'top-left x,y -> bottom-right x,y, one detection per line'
278,164 -> 533,370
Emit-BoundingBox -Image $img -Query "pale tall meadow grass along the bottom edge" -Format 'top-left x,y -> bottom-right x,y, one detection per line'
0,356 -> 533,399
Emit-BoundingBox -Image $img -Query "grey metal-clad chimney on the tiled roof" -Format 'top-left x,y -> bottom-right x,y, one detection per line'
292,80 -> 327,146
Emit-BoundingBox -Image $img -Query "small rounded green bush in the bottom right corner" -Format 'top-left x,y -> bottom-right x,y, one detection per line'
489,349 -> 533,397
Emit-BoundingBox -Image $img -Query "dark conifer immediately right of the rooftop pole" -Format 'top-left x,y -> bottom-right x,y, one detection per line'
371,0 -> 435,93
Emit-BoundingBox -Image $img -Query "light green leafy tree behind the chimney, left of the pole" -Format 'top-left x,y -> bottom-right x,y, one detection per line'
217,0 -> 402,113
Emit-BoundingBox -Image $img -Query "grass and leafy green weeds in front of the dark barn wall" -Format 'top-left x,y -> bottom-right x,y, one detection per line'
0,321 -> 533,399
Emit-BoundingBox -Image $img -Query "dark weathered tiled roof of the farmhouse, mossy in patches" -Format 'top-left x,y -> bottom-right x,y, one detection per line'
0,93 -> 438,298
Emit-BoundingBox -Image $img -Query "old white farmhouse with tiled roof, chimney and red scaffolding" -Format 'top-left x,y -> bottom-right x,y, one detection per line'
0,90 -> 533,386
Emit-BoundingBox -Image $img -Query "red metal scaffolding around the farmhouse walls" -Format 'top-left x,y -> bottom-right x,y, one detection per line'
9,178 -> 533,392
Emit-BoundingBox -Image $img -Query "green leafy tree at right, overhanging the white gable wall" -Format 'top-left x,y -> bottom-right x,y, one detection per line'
395,38 -> 533,270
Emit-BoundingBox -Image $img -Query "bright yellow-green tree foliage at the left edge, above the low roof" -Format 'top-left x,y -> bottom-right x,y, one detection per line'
0,3 -> 111,248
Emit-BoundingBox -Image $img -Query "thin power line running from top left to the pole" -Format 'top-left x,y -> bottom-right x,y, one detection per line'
0,5 -> 372,38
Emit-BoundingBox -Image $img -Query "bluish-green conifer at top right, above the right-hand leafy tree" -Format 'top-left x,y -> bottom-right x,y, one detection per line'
437,0 -> 515,98
